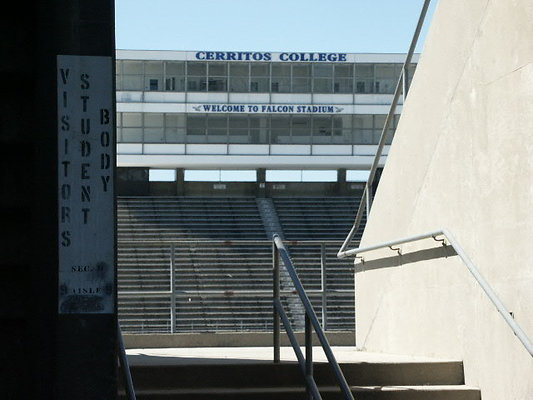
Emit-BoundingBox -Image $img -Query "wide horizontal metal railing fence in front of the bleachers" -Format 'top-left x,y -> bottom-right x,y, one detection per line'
118,240 -> 355,333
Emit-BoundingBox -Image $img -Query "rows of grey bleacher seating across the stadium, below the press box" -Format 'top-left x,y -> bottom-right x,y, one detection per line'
117,196 -> 354,333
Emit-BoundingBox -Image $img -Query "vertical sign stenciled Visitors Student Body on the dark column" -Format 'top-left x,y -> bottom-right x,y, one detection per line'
57,55 -> 115,314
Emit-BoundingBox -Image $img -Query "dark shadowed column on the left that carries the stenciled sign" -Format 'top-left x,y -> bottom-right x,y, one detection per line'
0,0 -> 117,400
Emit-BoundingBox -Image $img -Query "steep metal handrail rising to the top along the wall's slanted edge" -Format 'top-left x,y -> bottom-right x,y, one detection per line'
337,0 -> 431,258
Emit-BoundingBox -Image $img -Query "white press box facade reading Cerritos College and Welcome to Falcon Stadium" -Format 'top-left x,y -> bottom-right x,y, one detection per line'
116,50 -> 417,170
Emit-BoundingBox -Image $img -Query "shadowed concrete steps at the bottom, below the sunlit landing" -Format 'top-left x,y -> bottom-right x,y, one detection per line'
119,348 -> 481,400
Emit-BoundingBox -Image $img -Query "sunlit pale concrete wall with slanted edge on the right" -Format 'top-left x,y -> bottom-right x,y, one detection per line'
356,0 -> 533,400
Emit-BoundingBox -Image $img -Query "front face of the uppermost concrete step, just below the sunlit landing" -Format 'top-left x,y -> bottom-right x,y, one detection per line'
121,361 -> 463,389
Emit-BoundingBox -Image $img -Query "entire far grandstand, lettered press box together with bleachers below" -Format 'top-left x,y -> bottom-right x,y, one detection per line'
116,50 -> 416,338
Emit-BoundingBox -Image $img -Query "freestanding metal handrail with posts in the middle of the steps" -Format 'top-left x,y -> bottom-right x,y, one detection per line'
272,234 -> 353,400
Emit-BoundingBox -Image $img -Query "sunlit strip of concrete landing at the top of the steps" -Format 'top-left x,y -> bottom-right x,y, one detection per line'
126,346 -> 455,366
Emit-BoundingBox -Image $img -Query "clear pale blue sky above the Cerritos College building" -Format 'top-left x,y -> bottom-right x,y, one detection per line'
116,0 -> 437,53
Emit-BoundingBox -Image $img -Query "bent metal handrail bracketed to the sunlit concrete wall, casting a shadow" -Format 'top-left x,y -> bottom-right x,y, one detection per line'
342,229 -> 533,357
